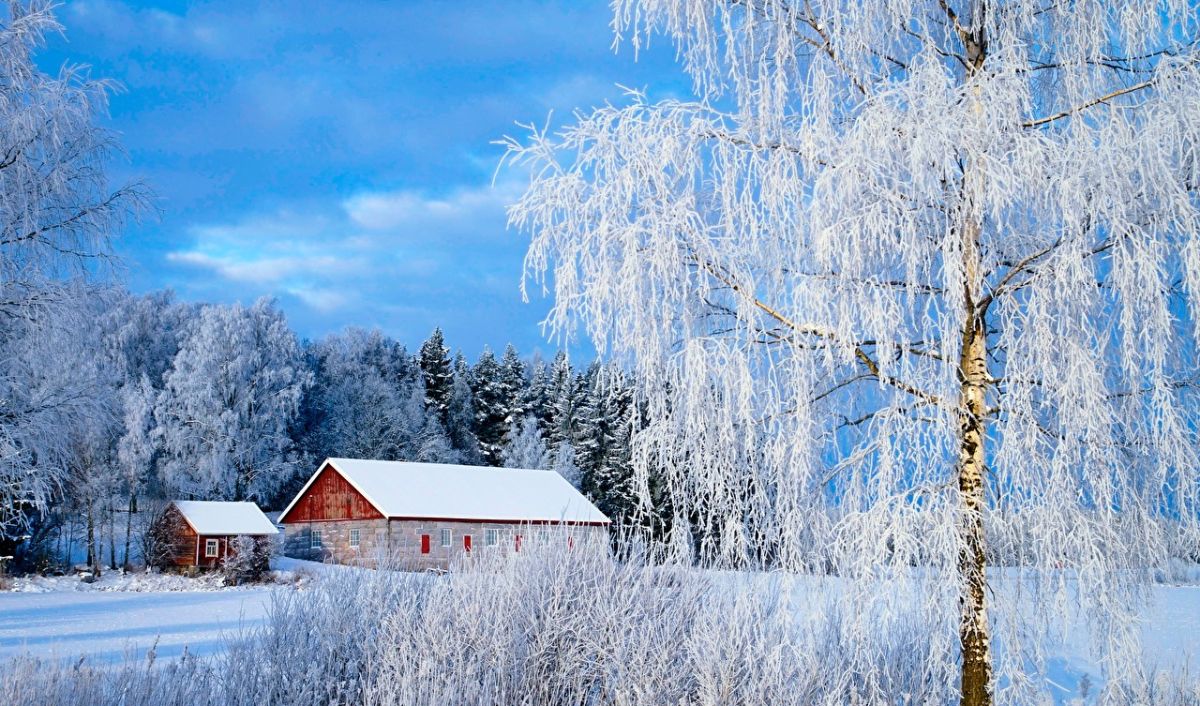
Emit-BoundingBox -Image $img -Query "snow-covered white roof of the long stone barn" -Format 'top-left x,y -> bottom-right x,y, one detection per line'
280,459 -> 610,525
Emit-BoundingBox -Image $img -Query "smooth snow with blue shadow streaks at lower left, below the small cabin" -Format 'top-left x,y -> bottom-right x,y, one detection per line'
0,588 -> 277,662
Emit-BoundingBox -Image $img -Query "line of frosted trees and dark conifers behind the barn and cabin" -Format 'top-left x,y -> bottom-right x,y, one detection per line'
0,283 -> 657,568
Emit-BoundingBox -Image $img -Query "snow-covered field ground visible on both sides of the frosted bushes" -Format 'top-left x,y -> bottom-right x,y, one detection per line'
0,560 -> 1200,704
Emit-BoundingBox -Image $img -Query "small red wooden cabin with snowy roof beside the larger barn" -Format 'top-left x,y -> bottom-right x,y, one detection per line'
155,501 -> 280,569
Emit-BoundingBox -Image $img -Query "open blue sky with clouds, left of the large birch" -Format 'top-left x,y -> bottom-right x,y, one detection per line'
38,0 -> 688,357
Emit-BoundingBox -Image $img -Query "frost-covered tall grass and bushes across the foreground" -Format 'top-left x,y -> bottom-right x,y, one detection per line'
0,546 -> 1200,706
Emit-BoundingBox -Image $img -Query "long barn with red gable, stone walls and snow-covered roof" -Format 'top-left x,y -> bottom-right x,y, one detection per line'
278,459 -> 610,569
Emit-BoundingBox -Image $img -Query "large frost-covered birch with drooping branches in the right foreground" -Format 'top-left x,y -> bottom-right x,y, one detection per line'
509,0 -> 1200,704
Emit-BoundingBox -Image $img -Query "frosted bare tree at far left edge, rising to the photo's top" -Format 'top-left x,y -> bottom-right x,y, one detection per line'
0,1 -> 144,555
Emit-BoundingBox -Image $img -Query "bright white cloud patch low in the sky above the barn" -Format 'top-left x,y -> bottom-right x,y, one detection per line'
167,178 -> 520,313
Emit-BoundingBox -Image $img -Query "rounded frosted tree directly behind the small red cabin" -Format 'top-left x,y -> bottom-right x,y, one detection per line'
155,299 -> 311,502
